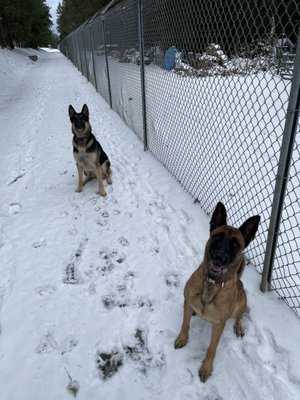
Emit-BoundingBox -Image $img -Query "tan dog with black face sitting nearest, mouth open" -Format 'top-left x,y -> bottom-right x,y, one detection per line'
174,202 -> 260,382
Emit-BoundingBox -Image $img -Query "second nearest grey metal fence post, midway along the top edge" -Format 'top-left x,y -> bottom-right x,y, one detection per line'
138,0 -> 148,151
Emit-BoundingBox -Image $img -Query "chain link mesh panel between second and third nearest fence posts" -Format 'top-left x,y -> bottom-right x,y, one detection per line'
105,0 -> 143,139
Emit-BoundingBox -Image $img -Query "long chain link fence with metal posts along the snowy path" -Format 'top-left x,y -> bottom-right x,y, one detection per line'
60,0 -> 300,315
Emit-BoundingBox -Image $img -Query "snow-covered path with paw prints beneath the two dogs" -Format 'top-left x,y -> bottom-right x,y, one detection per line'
0,49 -> 300,400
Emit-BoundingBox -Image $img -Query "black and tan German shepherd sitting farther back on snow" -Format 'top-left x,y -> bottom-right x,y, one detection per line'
69,104 -> 112,196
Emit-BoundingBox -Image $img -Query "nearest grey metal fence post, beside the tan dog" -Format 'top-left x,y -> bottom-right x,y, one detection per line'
260,29 -> 300,292
